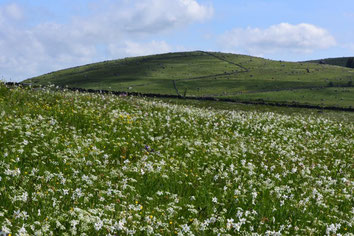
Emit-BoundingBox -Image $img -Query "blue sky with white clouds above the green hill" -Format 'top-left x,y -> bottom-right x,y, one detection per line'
0,0 -> 354,82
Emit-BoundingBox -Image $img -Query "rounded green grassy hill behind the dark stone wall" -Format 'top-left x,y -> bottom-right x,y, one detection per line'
25,51 -> 354,107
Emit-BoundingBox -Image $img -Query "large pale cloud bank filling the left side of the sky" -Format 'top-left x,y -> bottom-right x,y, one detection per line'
0,0 -> 213,81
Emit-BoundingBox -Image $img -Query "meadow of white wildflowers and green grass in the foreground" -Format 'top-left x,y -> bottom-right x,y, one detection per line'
0,84 -> 354,235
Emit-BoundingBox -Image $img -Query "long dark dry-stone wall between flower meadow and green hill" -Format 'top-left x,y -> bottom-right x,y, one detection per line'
5,82 -> 354,112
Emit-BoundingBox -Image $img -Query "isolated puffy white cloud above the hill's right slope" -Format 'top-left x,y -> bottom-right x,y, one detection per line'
221,23 -> 336,55
